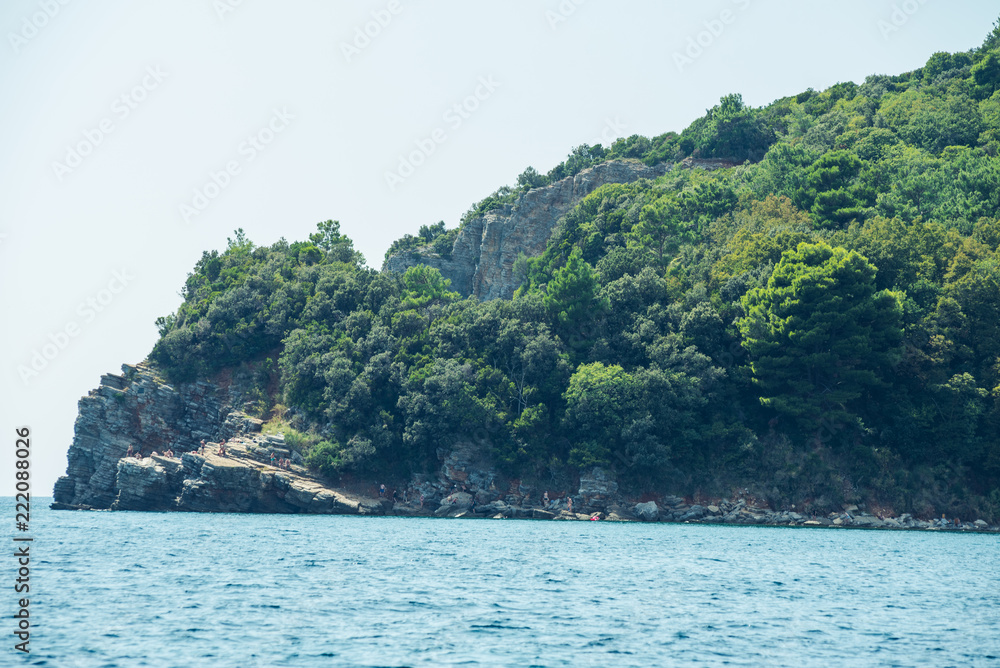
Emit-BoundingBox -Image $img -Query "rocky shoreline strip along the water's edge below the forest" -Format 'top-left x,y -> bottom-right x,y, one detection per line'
50,434 -> 1000,534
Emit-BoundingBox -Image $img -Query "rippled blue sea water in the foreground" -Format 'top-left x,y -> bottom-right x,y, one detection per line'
7,499 -> 1000,668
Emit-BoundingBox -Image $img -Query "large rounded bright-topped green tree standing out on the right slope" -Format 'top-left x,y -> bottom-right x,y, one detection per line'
738,242 -> 901,430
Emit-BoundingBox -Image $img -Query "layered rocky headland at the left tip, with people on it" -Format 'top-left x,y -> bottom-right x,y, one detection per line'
53,364 -> 391,515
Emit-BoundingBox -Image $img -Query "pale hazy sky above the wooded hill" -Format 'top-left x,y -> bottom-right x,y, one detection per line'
0,0 -> 1000,496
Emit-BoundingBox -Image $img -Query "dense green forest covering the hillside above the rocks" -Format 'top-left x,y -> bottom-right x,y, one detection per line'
151,20 -> 1000,521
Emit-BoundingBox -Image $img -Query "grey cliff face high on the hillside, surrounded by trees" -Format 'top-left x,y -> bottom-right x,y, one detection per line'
383,160 -> 673,300
